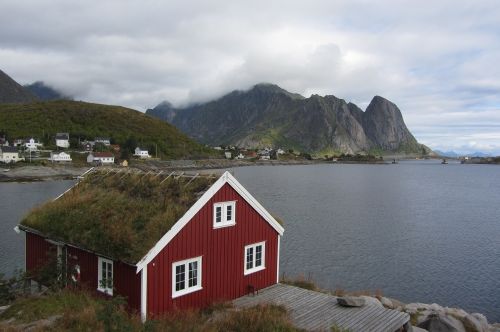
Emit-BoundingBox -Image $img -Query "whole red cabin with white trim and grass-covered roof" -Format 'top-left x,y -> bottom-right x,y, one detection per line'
18,171 -> 283,319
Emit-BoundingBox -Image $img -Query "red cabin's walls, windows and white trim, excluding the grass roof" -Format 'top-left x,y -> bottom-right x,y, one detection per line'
19,172 -> 283,319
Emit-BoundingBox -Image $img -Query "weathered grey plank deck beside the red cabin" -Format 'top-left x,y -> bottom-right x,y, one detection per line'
233,284 -> 410,332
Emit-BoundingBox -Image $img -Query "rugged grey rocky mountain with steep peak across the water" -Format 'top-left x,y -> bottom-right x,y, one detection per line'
146,84 -> 430,154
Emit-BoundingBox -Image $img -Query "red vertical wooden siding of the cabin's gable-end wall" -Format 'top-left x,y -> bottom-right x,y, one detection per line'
147,184 -> 278,316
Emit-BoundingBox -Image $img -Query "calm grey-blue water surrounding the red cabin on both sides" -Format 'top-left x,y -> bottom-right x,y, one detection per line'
0,161 -> 500,321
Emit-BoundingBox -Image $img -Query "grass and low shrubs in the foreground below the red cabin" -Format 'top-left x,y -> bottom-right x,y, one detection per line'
0,289 -> 298,332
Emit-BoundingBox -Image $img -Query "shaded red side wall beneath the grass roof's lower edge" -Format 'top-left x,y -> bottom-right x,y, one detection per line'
26,232 -> 141,311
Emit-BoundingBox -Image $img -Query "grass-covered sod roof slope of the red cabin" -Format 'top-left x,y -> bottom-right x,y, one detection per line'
21,171 -> 217,263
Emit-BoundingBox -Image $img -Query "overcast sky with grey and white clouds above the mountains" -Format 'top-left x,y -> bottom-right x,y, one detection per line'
0,0 -> 500,154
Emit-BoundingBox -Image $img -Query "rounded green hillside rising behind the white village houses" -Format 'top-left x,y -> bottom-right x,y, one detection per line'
0,100 -> 213,159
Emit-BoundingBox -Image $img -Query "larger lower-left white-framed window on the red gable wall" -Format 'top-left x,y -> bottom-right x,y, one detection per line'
172,256 -> 202,298
